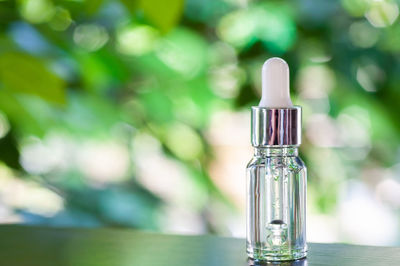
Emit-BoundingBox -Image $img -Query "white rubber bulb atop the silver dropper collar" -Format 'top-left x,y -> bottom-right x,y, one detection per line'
259,57 -> 293,108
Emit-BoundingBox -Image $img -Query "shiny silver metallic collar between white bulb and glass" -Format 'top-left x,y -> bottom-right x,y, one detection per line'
251,106 -> 301,147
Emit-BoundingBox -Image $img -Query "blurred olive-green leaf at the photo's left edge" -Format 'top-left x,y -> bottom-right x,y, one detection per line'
0,52 -> 65,104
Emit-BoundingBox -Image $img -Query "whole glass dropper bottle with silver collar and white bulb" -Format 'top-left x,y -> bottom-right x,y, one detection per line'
246,57 -> 307,261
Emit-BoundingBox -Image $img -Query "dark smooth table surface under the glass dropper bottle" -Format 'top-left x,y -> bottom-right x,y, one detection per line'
0,225 -> 400,266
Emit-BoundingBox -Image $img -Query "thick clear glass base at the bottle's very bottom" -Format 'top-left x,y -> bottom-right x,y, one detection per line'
247,248 -> 307,261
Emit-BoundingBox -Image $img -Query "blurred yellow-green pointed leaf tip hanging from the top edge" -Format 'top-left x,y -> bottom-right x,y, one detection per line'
139,0 -> 184,32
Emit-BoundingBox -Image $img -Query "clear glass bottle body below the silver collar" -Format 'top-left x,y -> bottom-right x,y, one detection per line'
247,146 -> 307,261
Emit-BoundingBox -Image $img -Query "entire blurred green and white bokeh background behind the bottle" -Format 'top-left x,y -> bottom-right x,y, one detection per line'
0,0 -> 400,245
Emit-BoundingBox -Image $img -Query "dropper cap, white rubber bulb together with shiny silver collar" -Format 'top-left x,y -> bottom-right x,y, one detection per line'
251,57 -> 301,147
